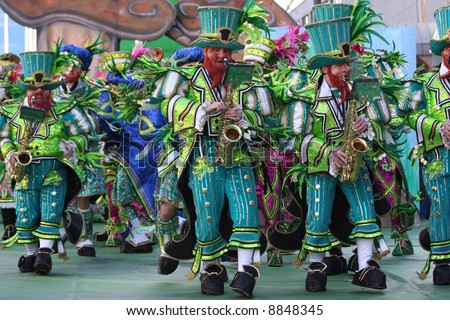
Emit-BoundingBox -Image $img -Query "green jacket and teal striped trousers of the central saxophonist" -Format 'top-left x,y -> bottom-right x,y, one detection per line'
155,66 -> 271,272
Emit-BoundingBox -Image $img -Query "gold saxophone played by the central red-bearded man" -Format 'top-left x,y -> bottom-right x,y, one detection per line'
216,59 -> 242,166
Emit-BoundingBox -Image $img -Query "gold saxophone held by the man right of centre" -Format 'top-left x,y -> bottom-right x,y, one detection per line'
339,99 -> 369,183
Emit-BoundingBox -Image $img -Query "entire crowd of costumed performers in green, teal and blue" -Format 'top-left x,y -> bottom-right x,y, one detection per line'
0,0 -> 450,298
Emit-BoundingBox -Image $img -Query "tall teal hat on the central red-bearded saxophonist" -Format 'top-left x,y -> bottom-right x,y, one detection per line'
191,6 -> 244,50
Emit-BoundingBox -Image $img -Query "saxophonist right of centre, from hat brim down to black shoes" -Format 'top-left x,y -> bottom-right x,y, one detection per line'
294,50 -> 389,291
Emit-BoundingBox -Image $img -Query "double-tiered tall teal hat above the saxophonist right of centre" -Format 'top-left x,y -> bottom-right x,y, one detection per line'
305,3 -> 353,69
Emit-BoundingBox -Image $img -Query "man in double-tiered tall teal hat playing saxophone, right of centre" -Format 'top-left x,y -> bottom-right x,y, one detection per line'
297,2 -> 390,292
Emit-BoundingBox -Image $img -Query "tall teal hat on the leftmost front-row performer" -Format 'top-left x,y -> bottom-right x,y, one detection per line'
17,51 -> 62,90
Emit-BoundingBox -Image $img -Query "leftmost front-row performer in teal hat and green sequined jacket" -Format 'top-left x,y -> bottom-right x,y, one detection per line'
1,51 -> 92,275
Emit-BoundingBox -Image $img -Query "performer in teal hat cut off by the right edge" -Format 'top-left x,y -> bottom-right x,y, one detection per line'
397,6 -> 450,285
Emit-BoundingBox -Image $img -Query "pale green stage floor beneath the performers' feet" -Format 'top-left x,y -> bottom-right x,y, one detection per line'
0,220 -> 450,300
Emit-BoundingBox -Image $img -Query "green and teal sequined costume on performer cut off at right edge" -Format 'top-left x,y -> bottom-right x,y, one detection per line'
398,65 -> 450,284
